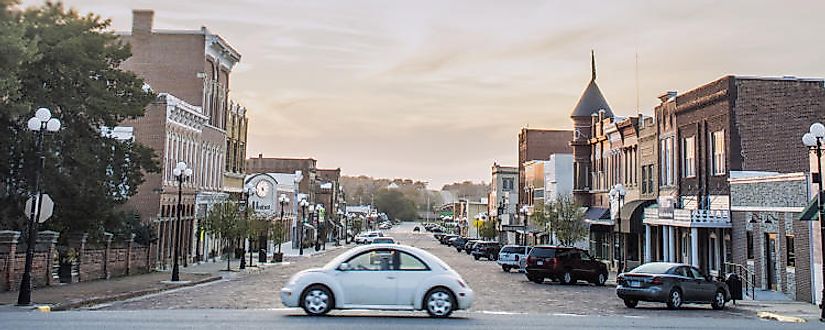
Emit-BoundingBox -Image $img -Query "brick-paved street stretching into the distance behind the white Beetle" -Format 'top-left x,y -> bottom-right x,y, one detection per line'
98,224 -> 751,318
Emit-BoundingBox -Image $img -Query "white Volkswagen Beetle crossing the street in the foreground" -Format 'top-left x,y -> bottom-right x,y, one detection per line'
281,244 -> 473,317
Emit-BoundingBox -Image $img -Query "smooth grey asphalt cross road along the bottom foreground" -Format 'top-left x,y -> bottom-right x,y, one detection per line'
0,309 -> 822,330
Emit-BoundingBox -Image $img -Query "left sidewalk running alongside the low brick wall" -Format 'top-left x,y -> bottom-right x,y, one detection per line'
0,260 -> 254,311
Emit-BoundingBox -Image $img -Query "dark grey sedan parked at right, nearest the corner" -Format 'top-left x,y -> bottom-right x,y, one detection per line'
616,262 -> 731,310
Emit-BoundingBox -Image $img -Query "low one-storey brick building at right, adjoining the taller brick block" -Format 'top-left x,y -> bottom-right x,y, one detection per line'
725,172 -> 819,302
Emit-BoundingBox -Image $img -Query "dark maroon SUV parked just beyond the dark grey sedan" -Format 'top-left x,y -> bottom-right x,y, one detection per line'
525,245 -> 608,286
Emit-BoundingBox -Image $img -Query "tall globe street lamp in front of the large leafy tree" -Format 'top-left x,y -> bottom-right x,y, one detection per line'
17,108 -> 60,306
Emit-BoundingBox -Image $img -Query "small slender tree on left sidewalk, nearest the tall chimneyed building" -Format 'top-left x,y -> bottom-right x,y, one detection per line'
203,201 -> 249,270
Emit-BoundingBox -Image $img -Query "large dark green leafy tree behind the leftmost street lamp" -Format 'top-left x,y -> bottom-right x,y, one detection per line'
0,0 -> 158,237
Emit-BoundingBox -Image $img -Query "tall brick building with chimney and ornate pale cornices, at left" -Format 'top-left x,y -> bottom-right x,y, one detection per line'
120,10 -> 247,266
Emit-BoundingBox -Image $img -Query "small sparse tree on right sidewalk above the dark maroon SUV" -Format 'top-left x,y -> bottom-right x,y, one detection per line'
548,194 -> 588,246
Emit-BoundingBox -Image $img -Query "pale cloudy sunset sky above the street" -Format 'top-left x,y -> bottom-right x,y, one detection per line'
23,0 -> 825,189
